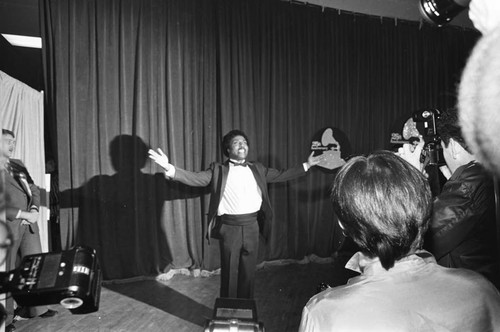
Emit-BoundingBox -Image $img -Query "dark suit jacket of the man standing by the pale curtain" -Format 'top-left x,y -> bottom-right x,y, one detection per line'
5,159 -> 40,227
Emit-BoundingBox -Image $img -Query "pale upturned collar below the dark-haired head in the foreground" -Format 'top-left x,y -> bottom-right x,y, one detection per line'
345,250 -> 436,276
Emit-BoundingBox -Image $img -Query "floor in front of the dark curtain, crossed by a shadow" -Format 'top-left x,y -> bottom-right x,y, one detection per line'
11,254 -> 353,332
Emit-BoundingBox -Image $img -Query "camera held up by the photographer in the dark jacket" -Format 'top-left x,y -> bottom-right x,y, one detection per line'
390,108 -> 446,167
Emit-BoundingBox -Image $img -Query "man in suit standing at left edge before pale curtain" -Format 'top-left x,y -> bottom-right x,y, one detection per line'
1,129 -> 57,331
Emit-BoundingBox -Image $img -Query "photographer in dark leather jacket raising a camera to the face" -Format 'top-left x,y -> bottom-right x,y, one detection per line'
398,109 -> 500,288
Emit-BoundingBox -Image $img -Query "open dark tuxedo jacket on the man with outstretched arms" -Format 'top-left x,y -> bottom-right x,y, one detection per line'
173,160 -> 306,239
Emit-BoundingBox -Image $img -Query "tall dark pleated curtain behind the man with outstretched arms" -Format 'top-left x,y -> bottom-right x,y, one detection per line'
41,0 -> 477,279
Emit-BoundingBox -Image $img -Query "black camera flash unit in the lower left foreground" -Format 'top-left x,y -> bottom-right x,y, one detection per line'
0,246 -> 102,314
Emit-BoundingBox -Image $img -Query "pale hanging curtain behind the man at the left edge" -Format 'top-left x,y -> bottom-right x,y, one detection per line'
0,71 -> 49,252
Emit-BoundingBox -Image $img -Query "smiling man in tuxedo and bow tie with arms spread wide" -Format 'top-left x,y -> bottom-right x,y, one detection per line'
149,130 -> 321,298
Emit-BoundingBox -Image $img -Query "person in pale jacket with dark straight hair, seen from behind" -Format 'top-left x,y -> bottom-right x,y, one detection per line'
300,151 -> 500,331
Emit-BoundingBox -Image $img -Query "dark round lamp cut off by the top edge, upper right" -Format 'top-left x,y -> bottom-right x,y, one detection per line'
418,0 -> 471,26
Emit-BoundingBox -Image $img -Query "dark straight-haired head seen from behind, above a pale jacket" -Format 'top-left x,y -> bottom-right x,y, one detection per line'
332,151 -> 432,270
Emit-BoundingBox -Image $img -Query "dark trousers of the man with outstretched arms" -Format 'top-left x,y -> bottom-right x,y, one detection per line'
219,213 -> 259,299
